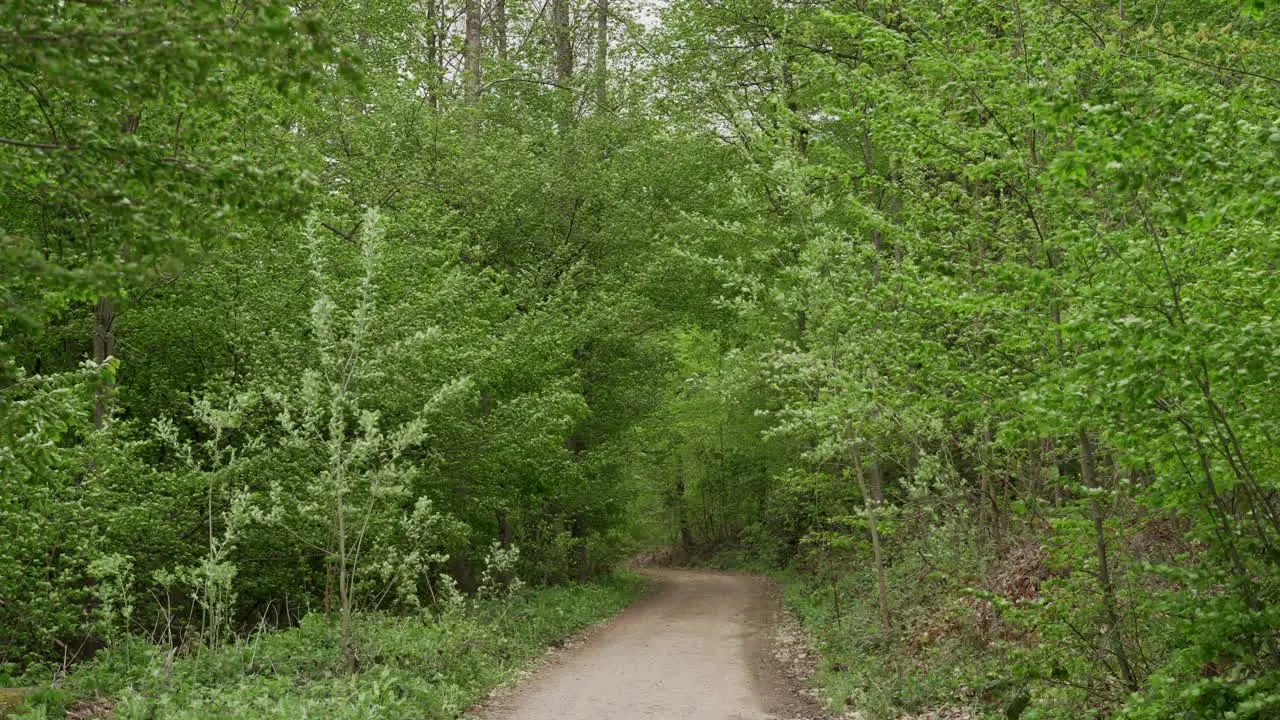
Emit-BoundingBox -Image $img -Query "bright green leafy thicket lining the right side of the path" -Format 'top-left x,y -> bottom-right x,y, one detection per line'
650,0 -> 1280,719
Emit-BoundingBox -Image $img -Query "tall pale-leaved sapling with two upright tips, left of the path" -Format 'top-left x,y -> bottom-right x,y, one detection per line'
268,210 -> 470,671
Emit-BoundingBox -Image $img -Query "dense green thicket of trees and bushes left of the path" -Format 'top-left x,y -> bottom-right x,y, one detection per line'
0,0 -> 700,716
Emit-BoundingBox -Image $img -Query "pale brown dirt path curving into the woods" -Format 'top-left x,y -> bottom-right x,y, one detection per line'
486,570 -> 817,720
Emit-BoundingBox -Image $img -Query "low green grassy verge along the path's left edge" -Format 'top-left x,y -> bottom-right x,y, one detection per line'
7,574 -> 644,720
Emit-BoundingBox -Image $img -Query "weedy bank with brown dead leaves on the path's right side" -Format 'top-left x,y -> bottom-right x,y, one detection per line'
696,525 -> 1187,720
